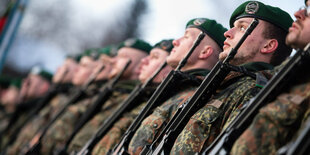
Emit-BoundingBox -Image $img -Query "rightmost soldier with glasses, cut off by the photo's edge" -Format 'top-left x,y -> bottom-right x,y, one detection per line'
231,0 -> 310,155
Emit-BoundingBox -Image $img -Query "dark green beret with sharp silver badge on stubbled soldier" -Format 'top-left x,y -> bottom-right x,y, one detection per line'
229,1 -> 293,32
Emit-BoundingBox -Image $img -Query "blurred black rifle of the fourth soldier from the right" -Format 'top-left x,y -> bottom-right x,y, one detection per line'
75,62 -> 167,154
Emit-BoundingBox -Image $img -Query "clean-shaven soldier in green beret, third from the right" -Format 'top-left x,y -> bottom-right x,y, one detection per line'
129,18 -> 226,154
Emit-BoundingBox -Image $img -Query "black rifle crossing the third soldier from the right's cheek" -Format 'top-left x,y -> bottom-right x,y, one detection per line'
108,32 -> 205,155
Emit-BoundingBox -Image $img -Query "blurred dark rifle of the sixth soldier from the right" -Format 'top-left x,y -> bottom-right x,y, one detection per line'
25,64 -> 104,155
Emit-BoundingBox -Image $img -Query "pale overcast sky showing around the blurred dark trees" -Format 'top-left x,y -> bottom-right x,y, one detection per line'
4,0 -> 304,72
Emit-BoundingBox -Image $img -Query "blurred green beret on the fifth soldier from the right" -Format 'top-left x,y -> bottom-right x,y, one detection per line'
118,38 -> 152,54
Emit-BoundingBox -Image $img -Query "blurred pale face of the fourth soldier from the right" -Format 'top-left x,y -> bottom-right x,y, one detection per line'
139,48 -> 168,83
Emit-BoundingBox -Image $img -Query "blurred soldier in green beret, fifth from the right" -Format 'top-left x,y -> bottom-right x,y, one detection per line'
65,38 -> 151,153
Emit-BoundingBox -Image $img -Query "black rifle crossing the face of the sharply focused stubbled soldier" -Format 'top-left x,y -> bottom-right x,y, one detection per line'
140,19 -> 258,155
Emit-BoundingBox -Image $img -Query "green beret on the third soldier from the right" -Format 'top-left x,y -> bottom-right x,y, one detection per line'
186,18 -> 227,48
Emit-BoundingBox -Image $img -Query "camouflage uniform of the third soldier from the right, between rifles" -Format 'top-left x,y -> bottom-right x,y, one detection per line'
128,69 -> 209,154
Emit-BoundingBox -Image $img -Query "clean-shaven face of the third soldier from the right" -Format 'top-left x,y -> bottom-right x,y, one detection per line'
167,28 -> 205,68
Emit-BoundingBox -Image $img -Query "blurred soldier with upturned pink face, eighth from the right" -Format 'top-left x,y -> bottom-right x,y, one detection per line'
7,57 -> 78,154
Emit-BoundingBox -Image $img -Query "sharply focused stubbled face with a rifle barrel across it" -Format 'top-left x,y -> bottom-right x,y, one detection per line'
219,18 -> 265,65
